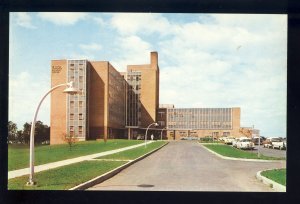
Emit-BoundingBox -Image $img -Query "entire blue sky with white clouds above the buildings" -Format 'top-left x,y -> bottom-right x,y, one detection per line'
9,12 -> 287,137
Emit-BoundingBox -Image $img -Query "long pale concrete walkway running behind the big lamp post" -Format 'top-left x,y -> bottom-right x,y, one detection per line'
8,141 -> 153,179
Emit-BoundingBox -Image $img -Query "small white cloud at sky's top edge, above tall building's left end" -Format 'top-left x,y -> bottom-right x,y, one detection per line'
38,12 -> 88,25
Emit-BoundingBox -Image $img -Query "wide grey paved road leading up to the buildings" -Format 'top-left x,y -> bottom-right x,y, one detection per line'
88,141 -> 285,192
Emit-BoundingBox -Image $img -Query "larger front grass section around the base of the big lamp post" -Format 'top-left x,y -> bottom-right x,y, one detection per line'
8,160 -> 126,190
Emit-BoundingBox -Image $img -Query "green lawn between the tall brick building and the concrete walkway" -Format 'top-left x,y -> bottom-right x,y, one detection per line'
8,140 -> 144,171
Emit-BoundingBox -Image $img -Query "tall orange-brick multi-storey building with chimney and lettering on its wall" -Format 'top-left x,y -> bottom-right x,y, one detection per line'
50,52 -> 159,144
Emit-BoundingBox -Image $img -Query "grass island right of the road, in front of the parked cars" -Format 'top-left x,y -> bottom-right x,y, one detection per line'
204,144 -> 284,160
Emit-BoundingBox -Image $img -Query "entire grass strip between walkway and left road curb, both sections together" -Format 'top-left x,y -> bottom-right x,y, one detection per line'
8,141 -> 166,190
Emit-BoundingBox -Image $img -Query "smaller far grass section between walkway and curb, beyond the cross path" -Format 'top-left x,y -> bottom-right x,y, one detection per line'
97,141 -> 166,160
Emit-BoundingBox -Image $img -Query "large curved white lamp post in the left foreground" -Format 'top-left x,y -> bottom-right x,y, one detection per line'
27,81 -> 80,186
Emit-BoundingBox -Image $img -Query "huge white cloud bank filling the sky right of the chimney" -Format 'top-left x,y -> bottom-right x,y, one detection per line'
155,15 -> 287,136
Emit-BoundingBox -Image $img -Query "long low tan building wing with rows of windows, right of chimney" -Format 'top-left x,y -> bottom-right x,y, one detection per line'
158,105 -> 243,140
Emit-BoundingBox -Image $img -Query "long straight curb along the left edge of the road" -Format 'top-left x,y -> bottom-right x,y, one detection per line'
69,142 -> 169,190
